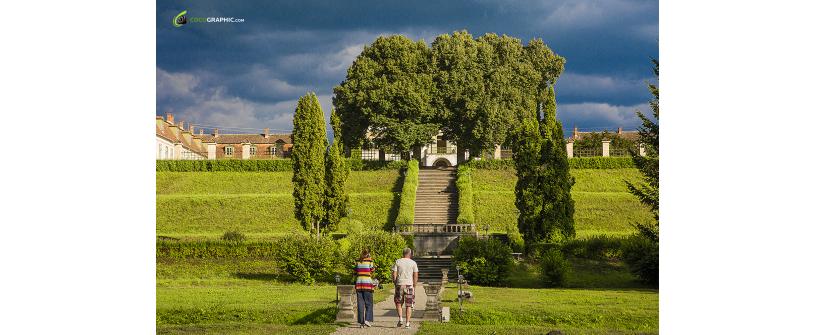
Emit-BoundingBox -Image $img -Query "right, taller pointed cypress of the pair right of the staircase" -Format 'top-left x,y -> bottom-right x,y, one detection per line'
540,86 -> 575,241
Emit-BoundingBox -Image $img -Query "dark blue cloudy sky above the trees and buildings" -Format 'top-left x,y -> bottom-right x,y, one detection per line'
156,0 -> 659,136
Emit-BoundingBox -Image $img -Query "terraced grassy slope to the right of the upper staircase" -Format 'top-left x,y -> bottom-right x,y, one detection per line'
473,169 -> 652,237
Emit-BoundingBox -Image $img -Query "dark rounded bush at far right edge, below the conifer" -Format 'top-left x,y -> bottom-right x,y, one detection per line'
622,234 -> 659,286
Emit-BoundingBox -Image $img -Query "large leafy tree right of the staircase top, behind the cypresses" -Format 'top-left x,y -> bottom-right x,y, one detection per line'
431,31 -> 564,160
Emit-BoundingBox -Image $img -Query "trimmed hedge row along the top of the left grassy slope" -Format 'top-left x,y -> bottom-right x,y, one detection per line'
156,158 -> 407,172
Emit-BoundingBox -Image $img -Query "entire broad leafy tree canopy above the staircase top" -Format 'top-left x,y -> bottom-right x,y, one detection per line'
334,31 -> 565,158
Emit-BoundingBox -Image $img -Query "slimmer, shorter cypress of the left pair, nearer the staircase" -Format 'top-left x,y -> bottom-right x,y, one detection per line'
325,108 -> 349,230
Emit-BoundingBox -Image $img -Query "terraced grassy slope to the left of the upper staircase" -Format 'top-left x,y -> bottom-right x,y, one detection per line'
156,170 -> 399,239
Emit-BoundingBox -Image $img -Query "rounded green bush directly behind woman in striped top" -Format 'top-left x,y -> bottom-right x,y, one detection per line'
341,230 -> 407,283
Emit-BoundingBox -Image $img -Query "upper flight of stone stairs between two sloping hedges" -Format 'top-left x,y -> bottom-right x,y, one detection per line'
413,168 -> 458,224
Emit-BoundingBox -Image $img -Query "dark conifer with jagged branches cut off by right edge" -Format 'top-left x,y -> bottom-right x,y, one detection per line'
626,59 -> 659,242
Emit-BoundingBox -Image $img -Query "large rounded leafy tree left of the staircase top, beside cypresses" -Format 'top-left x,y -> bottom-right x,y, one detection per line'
334,35 -> 439,159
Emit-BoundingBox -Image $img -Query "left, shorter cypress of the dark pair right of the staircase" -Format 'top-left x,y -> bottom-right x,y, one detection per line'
512,118 -> 543,248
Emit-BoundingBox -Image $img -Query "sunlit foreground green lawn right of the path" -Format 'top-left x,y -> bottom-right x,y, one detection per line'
421,284 -> 659,334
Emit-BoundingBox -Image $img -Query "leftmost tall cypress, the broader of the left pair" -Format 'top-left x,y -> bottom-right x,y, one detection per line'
291,92 -> 328,236
